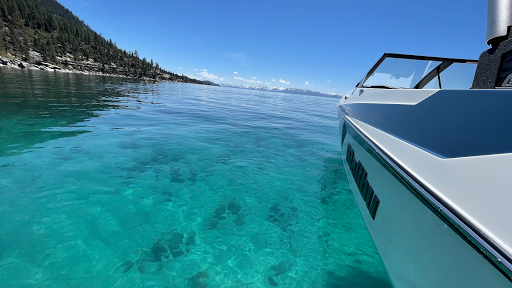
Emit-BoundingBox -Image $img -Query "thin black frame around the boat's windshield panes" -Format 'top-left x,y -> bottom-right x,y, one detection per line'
356,53 -> 478,89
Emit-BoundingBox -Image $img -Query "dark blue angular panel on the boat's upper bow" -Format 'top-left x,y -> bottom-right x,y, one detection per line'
339,90 -> 512,158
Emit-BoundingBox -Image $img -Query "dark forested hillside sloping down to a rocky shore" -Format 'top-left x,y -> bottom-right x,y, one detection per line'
0,0 -> 205,84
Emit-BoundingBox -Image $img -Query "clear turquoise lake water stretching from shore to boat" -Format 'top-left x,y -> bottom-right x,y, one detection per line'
0,68 -> 390,288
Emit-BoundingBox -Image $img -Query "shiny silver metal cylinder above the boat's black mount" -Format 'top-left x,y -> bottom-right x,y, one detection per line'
487,0 -> 512,46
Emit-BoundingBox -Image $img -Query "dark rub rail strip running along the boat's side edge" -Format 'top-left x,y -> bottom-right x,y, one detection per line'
336,103 -> 512,282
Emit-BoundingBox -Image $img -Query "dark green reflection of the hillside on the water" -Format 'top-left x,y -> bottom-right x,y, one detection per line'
0,68 -> 139,157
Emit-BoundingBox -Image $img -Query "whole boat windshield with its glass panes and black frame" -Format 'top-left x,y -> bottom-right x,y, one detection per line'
359,54 -> 477,89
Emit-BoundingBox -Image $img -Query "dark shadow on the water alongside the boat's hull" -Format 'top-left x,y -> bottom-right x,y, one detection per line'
319,154 -> 392,288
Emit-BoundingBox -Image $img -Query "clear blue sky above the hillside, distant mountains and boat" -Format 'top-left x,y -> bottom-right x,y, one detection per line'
58,0 -> 488,93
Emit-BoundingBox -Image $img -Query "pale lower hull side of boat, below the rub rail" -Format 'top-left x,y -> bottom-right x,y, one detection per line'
338,111 -> 512,288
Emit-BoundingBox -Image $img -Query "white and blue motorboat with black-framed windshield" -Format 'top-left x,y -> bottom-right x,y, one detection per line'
337,0 -> 512,287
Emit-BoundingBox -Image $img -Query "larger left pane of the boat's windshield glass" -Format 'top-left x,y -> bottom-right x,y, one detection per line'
364,57 -> 441,88
